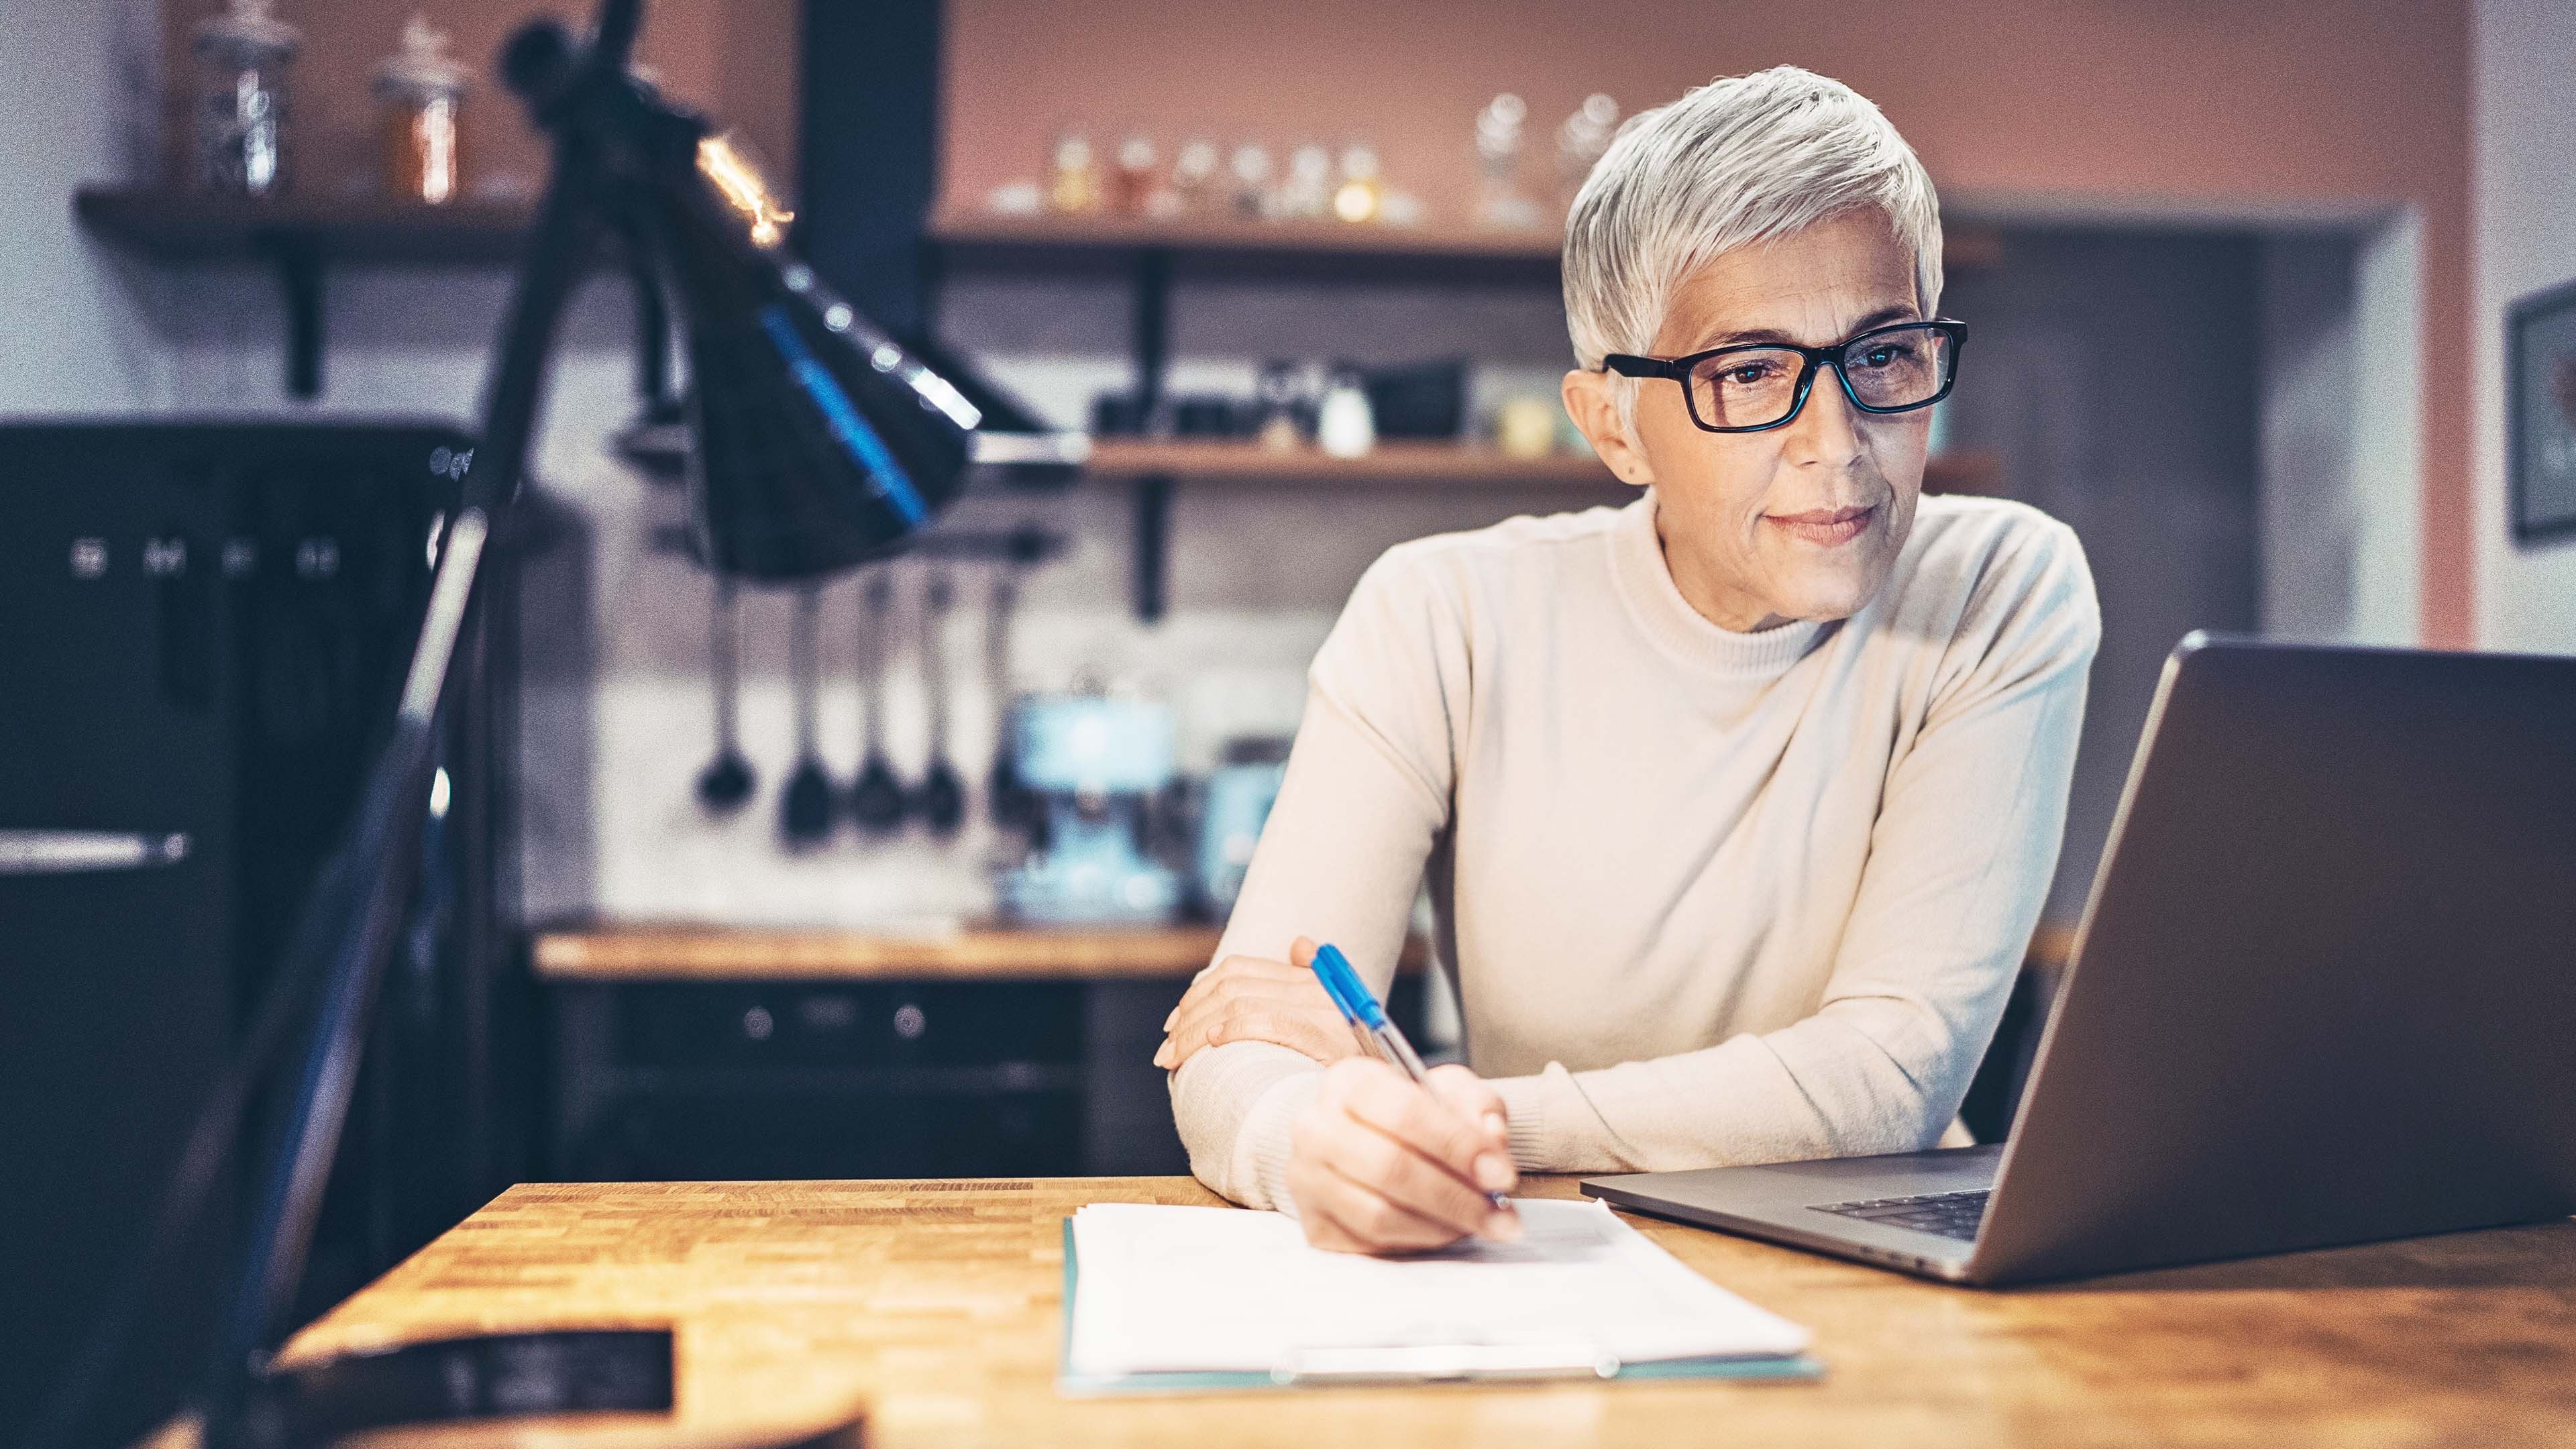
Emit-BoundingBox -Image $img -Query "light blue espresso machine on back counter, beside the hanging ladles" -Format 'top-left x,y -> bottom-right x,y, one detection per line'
1000,694 -> 1183,926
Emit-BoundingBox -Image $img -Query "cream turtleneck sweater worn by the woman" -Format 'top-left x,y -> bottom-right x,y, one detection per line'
1172,492 -> 2102,1210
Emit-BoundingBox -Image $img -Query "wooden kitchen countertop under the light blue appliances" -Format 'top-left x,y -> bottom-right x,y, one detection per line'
531,926 -> 1427,985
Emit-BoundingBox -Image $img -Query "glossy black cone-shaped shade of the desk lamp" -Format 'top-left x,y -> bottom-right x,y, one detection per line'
652,134 -> 984,580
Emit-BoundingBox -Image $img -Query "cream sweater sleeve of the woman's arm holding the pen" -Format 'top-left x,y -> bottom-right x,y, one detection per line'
1169,549 -> 1466,1212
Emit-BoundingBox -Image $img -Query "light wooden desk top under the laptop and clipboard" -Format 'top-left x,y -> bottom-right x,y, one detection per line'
288,1178 -> 2576,1449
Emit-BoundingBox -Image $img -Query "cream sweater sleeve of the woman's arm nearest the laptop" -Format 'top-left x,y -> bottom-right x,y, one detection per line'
1494,513 -> 2102,1171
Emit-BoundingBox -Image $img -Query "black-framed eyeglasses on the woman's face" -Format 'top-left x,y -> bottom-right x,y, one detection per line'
1602,317 -> 1968,433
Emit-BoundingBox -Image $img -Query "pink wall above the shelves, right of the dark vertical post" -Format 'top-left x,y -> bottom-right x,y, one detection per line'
943,0 -> 2473,645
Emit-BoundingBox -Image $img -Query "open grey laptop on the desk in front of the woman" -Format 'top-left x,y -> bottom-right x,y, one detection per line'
1582,634 -> 2576,1287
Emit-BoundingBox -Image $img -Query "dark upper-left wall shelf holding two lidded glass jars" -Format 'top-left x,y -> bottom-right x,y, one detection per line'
72,189 -> 531,266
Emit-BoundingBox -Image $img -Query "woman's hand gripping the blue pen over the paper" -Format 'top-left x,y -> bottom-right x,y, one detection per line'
1288,1057 -> 1520,1253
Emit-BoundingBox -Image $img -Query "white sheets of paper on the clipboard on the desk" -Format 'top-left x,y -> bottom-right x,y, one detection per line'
1067,1199 -> 1809,1379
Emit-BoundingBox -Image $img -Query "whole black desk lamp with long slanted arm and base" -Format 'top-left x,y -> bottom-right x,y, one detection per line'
28,0 -> 1007,1446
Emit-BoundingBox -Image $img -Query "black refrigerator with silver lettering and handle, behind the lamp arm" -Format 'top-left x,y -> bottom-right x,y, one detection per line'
0,420 -> 507,1441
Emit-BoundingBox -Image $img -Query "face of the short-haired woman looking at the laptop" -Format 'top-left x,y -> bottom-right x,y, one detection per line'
1566,209 -> 1932,629
